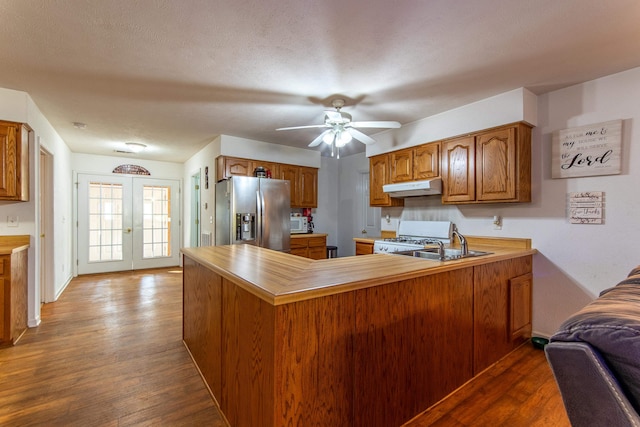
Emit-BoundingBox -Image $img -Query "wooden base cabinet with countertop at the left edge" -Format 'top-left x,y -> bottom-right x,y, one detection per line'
0,236 -> 29,346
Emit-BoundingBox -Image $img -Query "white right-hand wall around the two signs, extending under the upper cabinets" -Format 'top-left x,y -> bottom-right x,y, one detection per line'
372,68 -> 640,336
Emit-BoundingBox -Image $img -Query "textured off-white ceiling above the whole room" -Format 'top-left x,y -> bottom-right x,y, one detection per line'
0,0 -> 640,162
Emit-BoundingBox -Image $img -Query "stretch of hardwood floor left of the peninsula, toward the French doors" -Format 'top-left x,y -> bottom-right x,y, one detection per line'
0,269 -> 226,427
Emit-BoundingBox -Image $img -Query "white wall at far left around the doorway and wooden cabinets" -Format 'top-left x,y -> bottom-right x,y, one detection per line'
0,88 -> 72,327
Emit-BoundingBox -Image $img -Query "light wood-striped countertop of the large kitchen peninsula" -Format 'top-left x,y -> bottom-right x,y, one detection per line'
182,235 -> 537,305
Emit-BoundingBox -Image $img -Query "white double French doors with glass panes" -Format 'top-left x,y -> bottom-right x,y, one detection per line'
77,174 -> 180,274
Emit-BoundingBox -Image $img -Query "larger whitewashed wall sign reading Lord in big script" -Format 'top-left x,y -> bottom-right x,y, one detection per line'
551,120 -> 622,178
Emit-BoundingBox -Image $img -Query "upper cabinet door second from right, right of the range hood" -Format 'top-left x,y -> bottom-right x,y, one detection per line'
442,136 -> 476,203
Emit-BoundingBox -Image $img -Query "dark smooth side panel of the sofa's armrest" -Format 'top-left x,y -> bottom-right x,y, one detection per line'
545,342 -> 640,427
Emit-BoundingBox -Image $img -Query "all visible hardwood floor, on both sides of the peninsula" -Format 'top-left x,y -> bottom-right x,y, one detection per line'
0,269 -> 569,427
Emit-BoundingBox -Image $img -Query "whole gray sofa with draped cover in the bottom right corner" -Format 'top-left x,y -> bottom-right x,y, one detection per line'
545,266 -> 640,427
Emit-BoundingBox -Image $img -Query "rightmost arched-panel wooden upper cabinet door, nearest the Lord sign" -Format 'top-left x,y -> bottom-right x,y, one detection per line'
476,127 -> 518,201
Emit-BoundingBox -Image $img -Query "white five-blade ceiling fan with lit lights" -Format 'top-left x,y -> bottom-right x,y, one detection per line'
276,98 -> 400,158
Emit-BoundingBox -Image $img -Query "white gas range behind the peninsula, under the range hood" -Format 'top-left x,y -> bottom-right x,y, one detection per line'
373,221 -> 452,254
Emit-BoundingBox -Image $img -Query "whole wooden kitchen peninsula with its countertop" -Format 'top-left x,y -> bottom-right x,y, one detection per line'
183,237 -> 535,427
